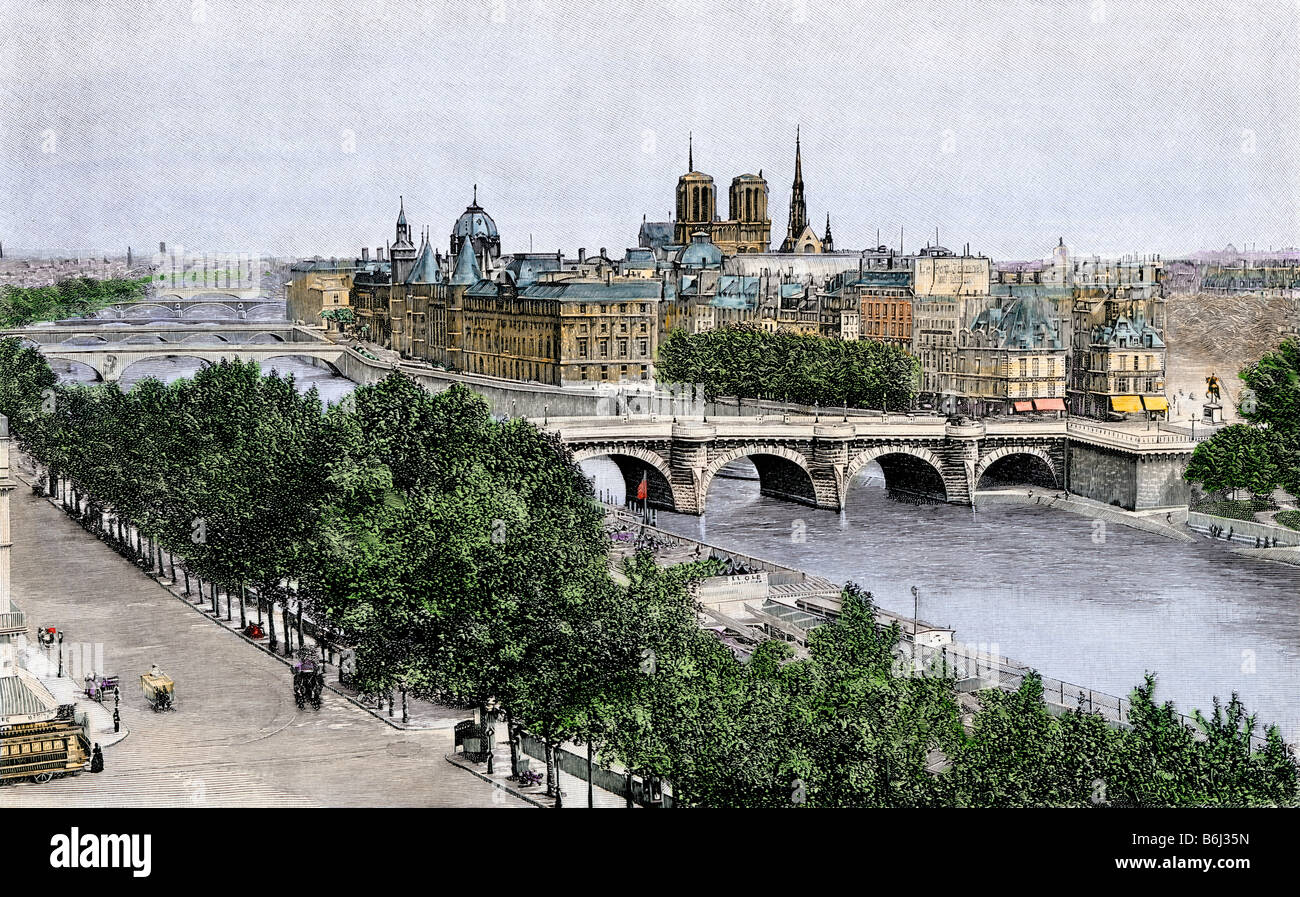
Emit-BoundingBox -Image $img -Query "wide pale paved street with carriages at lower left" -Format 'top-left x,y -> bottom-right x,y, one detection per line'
0,485 -> 527,807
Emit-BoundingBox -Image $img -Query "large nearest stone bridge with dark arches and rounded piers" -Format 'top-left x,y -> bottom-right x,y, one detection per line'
536,416 -> 1193,514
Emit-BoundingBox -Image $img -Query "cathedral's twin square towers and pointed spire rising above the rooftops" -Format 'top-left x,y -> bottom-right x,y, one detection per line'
673,129 -> 835,255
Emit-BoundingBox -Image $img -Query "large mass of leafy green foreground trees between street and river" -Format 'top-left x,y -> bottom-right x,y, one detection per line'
0,339 -> 1297,806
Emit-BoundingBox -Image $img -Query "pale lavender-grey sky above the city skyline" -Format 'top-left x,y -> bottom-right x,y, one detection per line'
0,0 -> 1300,259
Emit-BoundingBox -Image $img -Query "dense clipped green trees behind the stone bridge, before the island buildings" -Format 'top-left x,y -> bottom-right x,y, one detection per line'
655,324 -> 920,410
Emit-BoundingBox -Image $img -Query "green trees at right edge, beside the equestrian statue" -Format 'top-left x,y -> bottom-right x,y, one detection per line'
1184,339 -> 1300,498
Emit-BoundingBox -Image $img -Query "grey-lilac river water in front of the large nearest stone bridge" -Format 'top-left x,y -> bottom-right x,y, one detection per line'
582,458 -> 1300,744
